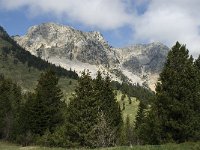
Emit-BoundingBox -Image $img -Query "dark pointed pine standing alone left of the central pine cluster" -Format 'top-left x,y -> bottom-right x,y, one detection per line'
25,69 -> 64,135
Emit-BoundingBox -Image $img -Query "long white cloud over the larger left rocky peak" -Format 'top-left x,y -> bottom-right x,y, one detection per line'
0,0 -> 133,29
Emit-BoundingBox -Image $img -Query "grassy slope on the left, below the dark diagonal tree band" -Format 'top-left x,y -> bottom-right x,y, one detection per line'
0,38 -> 77,98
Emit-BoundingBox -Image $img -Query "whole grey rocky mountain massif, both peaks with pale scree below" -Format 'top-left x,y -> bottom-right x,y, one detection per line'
14,23 -> 169,89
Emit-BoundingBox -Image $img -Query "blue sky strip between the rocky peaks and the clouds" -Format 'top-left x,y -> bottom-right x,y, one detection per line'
0,10 -> 133,47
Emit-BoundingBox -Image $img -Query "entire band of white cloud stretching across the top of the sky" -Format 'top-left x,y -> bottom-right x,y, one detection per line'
0,0 -> 200,56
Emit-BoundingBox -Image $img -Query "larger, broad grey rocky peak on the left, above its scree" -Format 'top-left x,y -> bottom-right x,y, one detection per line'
15,23 -> 118,66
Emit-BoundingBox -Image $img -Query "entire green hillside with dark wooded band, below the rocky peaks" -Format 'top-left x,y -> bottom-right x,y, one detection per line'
0,27 -> 155,119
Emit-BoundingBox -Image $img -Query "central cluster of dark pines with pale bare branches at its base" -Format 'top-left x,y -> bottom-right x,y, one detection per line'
66,72 -> 122,147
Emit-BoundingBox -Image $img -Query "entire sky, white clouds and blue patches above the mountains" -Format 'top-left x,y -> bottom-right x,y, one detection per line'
0,0 -> 200,57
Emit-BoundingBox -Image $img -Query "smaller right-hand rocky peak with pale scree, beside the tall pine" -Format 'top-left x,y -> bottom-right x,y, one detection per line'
115,42 -> 169,89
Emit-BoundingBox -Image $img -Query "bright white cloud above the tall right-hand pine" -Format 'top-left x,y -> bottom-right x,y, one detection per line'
134,0 -> 200,57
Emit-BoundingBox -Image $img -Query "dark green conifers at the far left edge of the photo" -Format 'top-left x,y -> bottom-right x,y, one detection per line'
0,75 -> 22,139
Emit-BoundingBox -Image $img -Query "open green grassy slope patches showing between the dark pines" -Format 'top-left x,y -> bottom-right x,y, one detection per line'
0,27 -> 139,125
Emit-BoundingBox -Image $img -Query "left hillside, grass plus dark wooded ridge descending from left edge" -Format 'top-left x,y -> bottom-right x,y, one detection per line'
0,27 -> 78,91
